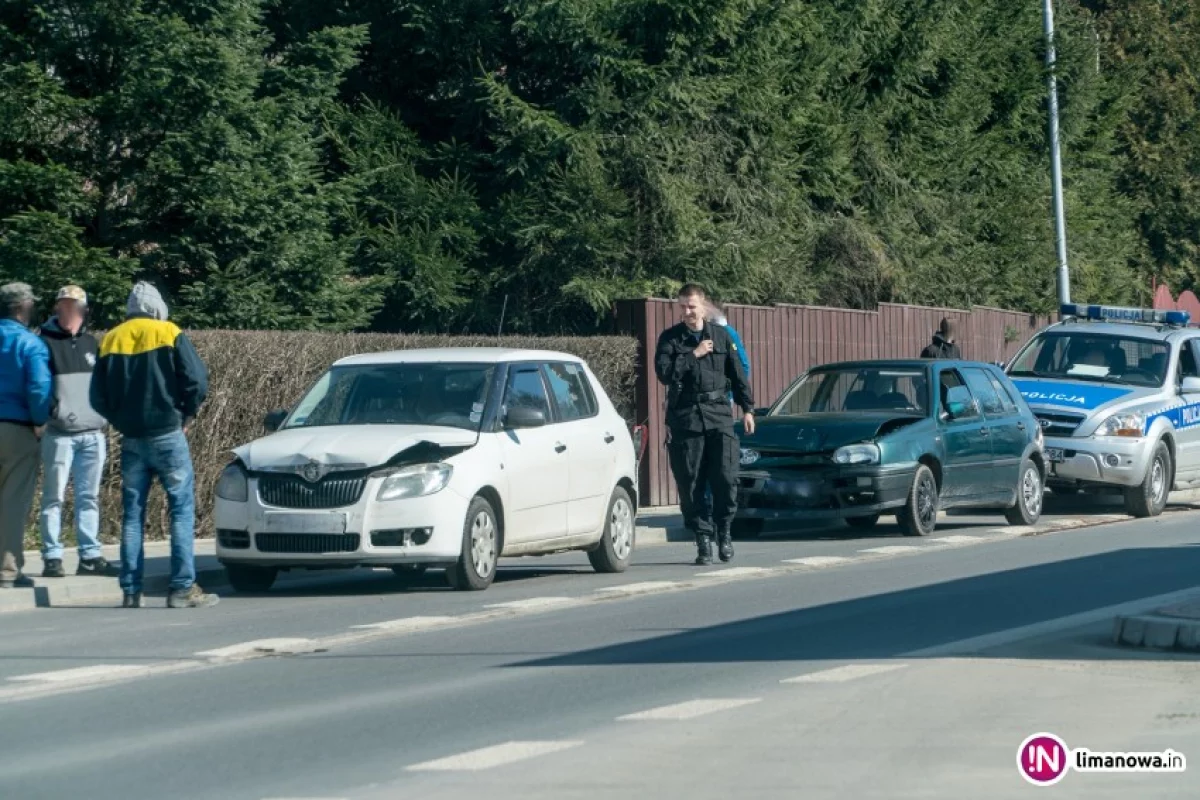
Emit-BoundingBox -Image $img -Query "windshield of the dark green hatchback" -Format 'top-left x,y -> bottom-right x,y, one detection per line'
770,367 -> 929,416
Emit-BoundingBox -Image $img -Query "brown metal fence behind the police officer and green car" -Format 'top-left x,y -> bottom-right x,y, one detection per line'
617,300 -> 1050,506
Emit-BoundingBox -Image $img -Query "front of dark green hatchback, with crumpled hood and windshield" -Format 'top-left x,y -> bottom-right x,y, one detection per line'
737,365 -> 937,524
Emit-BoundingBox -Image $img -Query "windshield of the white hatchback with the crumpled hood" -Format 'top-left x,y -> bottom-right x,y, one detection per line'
283,363 -> 496,431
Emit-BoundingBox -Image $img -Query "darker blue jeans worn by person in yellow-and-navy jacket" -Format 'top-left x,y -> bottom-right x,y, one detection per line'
120,431 -> 196,595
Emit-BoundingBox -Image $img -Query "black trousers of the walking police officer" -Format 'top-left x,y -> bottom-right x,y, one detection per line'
670,427 -> 738,547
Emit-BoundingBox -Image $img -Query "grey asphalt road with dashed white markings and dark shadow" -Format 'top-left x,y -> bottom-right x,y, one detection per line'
0,501 -> 1200,800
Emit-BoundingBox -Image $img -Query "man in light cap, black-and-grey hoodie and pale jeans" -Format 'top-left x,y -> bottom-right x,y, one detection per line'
41,285 -> 116,578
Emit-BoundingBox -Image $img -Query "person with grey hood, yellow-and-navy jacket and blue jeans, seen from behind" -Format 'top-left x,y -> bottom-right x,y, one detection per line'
91,283 -> 220,608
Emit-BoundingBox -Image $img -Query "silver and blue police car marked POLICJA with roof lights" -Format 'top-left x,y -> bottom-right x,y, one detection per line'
1007,303 -> 1200,517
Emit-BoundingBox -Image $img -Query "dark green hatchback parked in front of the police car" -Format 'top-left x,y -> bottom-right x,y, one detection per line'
733,360 -> 1045,539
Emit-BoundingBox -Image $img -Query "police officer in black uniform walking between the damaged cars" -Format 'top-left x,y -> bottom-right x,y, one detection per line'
654,283 -> 755,565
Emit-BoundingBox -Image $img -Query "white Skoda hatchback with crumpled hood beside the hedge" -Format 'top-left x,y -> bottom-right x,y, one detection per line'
215,348 -> 637,591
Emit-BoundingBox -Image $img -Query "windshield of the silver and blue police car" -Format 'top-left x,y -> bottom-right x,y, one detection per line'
1008,331 -> 1171,386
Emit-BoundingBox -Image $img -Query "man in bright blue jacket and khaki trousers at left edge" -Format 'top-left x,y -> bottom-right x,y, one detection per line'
0,283 -> 53,589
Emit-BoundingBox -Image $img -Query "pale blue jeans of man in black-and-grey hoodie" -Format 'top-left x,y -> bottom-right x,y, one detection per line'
41,431 -> 108,559
